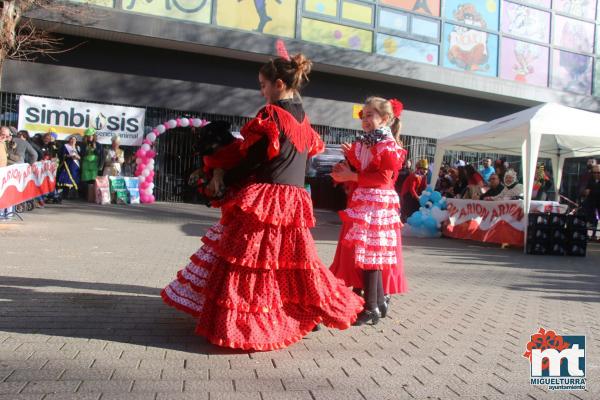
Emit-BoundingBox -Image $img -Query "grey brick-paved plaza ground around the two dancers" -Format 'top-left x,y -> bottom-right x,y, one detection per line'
0,202 -> 600,400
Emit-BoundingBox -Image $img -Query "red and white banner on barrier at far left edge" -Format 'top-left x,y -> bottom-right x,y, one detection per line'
0,160 -> 56,208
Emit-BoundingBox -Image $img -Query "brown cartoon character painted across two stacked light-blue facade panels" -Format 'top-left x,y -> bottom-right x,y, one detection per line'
447,3 -> 489,71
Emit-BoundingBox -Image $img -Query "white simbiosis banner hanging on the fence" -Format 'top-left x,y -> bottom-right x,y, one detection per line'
18,96 -> 146,146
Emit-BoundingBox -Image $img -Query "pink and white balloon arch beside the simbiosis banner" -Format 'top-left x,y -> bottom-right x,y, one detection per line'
135,118 -> 208,203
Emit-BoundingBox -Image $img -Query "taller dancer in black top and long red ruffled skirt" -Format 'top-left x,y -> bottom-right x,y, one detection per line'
162,54 -> 363,351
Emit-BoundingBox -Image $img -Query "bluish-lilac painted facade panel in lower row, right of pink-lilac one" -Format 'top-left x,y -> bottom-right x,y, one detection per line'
551,50 -> 592,94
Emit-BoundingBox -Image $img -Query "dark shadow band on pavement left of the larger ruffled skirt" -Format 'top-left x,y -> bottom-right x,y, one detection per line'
0,276 -> 244,354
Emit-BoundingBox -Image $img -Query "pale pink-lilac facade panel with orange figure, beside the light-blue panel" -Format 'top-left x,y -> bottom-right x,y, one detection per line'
500,38 -> 550,86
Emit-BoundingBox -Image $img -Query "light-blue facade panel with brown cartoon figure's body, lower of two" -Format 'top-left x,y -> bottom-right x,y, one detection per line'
442,24 -> 498,76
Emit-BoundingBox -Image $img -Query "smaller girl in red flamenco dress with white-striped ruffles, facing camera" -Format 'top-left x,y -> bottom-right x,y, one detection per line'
330,97 -> 407,325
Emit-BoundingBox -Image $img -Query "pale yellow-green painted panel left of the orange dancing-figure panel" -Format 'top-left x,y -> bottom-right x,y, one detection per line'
123,0 -> 211,23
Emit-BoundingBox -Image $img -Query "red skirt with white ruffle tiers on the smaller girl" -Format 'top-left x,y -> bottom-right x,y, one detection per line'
330,188 -> 408,294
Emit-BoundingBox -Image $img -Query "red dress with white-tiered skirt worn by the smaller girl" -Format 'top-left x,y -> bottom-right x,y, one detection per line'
330,134 -> 407,294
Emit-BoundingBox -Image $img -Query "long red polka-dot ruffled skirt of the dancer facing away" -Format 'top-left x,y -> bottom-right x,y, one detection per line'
161,184 -> 363,350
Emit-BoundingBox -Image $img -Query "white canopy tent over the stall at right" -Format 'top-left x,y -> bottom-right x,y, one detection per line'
431,103 -> 600,213
